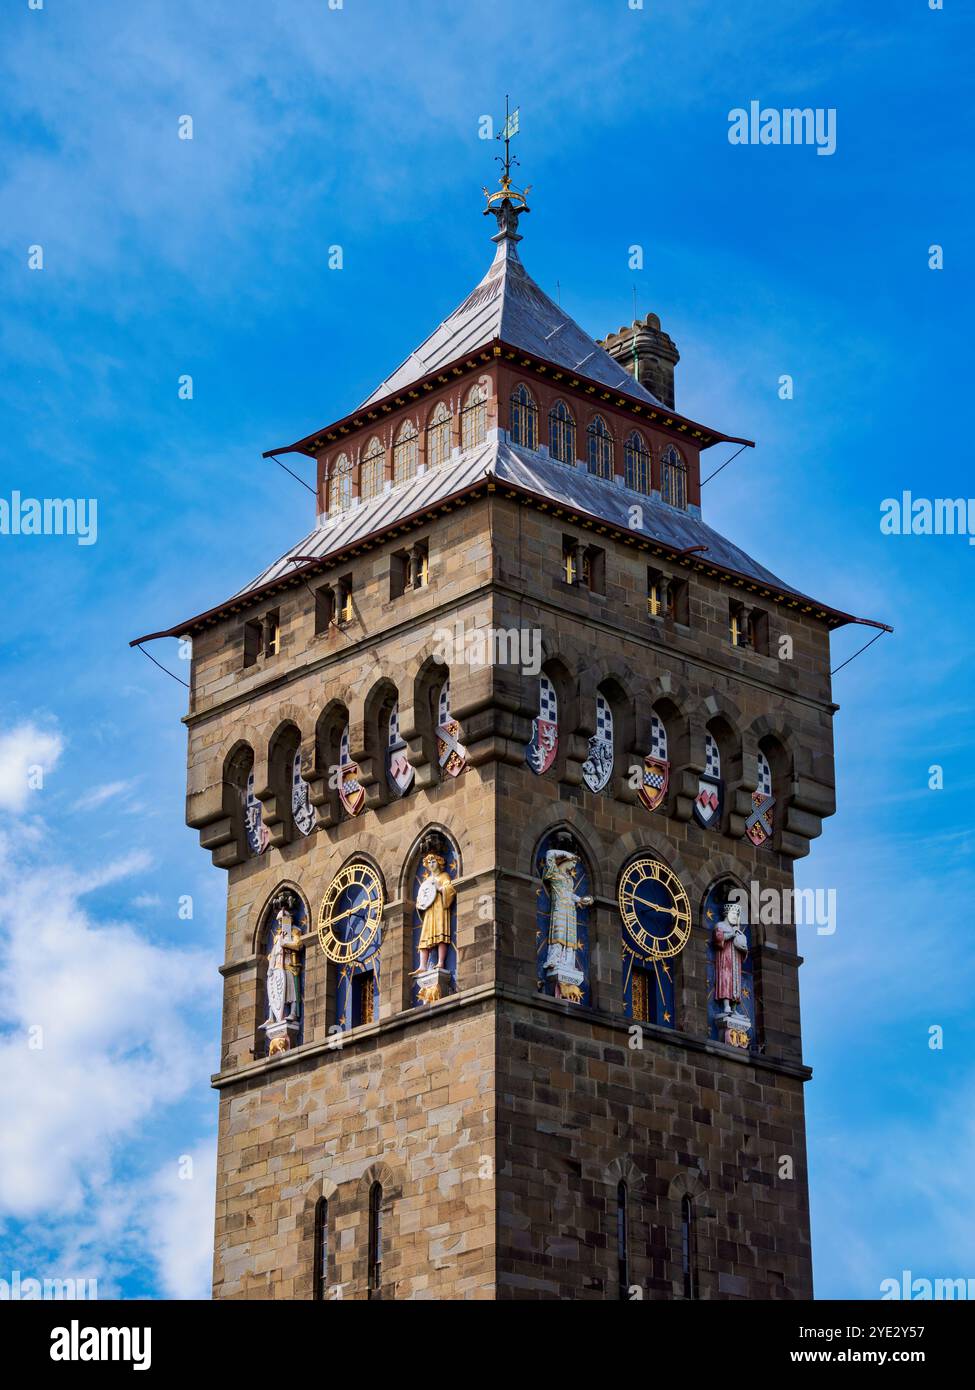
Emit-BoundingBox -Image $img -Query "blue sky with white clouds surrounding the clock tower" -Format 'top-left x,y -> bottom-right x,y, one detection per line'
0,0 -> 975,1298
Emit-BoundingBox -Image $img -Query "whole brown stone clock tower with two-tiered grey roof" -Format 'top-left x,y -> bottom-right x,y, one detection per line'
134,168 -> 884,1300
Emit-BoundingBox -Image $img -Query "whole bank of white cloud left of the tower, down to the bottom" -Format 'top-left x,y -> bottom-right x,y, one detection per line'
0,724 -> 218,1297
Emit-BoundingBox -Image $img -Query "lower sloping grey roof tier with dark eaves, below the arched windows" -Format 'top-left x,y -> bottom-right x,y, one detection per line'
131,441 -> 890,646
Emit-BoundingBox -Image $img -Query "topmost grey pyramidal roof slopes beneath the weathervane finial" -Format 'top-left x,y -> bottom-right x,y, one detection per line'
360,231 -> 666,409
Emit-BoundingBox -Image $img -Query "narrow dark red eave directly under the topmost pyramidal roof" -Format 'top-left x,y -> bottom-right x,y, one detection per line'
263,338 -> 755,459
